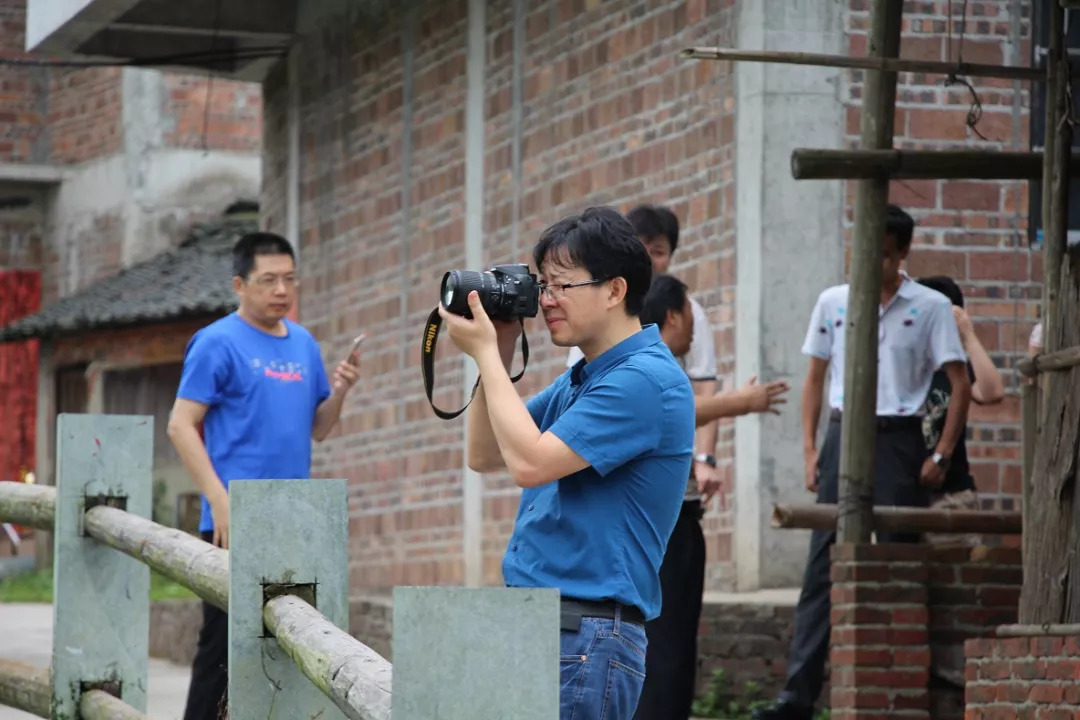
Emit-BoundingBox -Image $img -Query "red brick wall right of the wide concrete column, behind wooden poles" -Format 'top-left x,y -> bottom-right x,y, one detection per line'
843,0 -> 1028,518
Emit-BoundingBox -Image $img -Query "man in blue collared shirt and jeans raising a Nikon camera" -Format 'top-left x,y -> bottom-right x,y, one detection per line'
440,207 -> 694,720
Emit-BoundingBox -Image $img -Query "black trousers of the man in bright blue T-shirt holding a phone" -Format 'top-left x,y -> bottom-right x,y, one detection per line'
184,532 -> 229,720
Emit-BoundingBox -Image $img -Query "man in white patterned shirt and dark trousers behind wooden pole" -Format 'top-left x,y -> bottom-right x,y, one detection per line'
753,205 -> 971,720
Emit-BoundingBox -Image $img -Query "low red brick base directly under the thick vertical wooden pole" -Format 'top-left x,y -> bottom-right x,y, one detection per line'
829,544 -> 1019,720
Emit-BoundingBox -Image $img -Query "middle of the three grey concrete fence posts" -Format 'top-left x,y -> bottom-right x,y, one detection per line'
229,479 -> 349,720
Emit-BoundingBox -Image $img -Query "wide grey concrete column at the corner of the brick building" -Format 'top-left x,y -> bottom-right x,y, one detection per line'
734,0 -> 848,590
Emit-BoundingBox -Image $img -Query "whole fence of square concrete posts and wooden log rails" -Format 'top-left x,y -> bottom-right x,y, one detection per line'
0,413 -> 559,720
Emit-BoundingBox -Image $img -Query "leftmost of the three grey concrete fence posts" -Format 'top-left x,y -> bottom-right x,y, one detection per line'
52,413 -> 153,720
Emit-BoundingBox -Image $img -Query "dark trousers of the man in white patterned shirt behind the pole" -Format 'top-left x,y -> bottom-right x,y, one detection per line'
780,418 -> 930,708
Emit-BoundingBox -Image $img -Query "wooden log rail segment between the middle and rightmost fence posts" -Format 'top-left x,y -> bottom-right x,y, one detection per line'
262,595 -> 392,720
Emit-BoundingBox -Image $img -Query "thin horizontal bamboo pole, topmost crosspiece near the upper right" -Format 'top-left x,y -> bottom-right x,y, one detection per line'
681,47 -> 1047,82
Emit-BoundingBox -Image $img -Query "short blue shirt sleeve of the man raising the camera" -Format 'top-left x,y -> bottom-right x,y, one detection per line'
550,367 -> 662,477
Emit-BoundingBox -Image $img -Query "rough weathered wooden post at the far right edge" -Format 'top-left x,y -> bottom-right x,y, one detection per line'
1020,2 -> 1080,625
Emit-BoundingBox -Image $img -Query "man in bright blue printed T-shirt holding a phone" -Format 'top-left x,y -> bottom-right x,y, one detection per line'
168,232 -> 360,720
